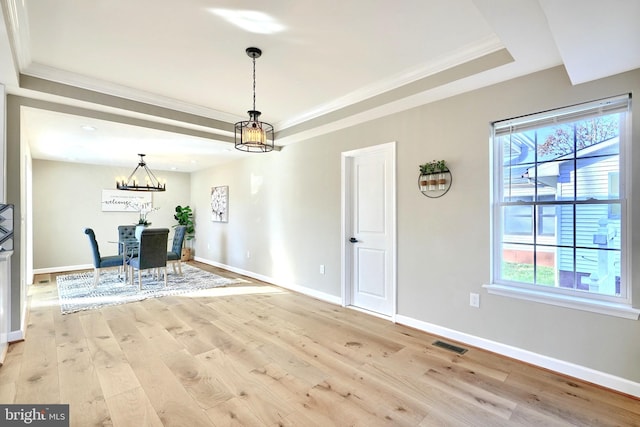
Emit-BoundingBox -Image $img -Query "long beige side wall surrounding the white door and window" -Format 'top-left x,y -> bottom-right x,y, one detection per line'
191,67 -> 640,383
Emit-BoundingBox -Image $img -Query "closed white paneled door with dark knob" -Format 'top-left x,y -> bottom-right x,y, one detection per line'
343,143 -> 396,316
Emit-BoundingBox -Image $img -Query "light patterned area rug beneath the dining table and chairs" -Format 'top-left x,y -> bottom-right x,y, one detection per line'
56,264 -> 241,314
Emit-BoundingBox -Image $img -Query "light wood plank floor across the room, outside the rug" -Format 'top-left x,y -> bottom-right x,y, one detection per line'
0,263 -> 640,427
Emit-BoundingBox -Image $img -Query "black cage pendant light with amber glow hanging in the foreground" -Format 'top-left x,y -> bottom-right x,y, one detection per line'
235,47 -> 273,153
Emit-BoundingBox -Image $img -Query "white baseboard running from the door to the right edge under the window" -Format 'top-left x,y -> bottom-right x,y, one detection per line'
396,315 -> 640,398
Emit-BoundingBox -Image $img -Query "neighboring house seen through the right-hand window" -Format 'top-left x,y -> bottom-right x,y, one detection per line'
503,125 -> 621,295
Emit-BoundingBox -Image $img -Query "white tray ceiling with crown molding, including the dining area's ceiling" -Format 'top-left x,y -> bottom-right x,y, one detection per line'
0,0 -> 640,171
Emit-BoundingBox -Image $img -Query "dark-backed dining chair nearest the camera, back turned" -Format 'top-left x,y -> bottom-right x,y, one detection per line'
127,228 -> 169,289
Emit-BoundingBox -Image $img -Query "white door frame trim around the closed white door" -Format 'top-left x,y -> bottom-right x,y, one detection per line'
340,141 -> 398,322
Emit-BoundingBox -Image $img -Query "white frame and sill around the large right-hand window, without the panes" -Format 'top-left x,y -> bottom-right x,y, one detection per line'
484,94 -> 640,320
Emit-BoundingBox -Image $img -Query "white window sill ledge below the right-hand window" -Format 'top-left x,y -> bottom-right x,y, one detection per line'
482,284 -> 640,320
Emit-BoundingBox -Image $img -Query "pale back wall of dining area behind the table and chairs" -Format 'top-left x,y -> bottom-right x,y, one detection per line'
33,160 -> 191,272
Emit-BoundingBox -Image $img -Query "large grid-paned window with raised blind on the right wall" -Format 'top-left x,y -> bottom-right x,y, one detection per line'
488,95 -> 631,307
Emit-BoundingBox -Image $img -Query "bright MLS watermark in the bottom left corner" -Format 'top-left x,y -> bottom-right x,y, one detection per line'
0,405 -> 69,427
